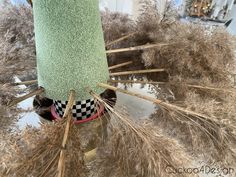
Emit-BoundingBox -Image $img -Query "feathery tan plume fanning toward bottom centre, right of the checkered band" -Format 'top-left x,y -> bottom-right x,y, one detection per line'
90,92 -> 191,177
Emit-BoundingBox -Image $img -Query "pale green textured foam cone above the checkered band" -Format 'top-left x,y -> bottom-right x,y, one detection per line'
33,0 -> 109,101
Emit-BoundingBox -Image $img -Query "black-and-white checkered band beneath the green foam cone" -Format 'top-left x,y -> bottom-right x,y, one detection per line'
53,98 -> 98,120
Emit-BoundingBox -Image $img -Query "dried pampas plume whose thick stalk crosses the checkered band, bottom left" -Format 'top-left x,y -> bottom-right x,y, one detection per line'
1,90 -> 86,177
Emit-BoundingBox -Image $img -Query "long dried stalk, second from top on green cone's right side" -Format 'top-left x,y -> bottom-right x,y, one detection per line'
106,43 -> 171,54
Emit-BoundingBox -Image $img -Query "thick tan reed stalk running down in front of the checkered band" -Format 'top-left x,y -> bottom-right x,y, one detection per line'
57,90 -> 75,177
